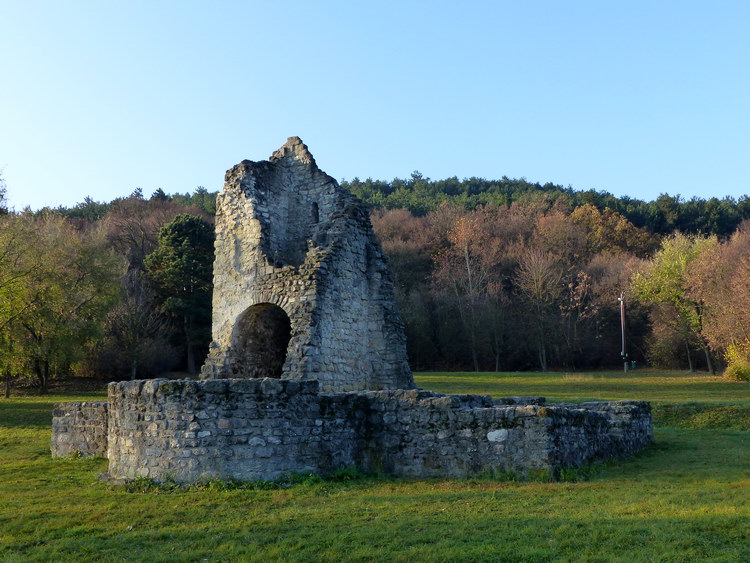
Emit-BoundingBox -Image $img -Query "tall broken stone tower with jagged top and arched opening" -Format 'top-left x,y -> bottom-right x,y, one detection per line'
202,137 -> 414,391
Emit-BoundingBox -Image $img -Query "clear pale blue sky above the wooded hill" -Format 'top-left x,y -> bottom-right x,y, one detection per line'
0,0 -> 750,210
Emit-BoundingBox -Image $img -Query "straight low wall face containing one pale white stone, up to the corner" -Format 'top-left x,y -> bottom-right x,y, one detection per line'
346,390 -> 550,477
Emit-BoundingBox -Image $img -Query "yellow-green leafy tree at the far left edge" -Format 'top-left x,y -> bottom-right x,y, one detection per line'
0,213 -> 123,393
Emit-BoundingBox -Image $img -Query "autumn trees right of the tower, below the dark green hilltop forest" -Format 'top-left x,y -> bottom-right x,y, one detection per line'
373,203 -> 750,372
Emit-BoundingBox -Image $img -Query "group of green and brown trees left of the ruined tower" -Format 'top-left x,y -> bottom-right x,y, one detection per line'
0,187 -> 214,396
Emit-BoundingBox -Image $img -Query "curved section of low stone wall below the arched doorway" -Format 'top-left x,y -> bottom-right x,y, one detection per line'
108,379 -> 364,482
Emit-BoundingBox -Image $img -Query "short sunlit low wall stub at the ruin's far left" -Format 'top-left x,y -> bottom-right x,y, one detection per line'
52,402 -> 108,457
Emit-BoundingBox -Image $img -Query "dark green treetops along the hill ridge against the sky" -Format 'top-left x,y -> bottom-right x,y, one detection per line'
27,176 -> 750,238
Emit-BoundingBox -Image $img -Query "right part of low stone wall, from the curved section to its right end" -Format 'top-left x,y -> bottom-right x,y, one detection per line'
348,390 -> 651,477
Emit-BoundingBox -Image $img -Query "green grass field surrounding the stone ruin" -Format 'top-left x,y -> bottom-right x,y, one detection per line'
0,371 -> 750,562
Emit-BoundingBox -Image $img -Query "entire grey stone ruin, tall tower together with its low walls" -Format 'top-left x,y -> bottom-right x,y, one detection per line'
52,137 -> 652,483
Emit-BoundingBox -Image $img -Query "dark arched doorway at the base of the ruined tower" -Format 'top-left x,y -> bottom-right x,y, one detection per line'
232,303 -> 291,378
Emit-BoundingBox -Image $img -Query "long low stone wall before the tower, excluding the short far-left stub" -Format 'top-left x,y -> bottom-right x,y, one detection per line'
97,379 -> 651,482
